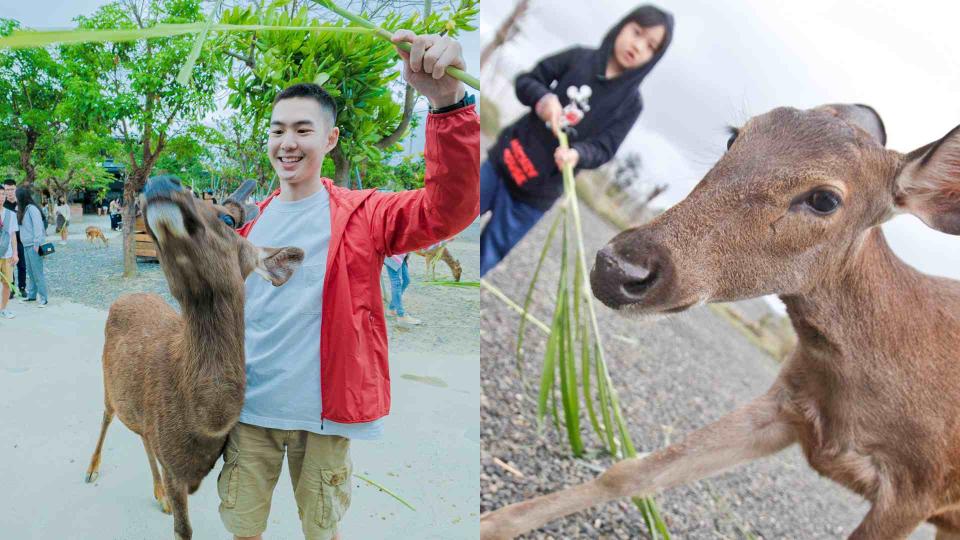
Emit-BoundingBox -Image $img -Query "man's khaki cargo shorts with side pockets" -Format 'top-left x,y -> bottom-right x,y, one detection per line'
217,422 -> 353,540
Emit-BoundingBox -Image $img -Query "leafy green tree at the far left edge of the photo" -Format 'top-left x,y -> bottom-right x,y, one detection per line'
0,19 -> 64,185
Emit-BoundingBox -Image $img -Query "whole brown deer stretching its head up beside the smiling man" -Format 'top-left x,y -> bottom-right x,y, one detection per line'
86,176 -> 303,540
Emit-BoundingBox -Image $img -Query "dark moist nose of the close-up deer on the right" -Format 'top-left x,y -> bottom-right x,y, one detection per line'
590,244 -> 661,309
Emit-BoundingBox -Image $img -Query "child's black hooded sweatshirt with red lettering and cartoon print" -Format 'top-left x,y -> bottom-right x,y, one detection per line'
488,5 -> 673,210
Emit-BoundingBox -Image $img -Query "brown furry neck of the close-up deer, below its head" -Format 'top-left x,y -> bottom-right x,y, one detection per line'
780,227 -> 926,361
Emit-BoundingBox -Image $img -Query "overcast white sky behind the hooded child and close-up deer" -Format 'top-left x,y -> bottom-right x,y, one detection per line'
480,0 -> 960,300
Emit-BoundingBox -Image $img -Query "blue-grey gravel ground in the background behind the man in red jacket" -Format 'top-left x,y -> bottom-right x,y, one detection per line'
37,215 -> 480,354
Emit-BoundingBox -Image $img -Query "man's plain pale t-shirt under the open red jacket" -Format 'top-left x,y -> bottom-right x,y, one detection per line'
240,188 -> 383,439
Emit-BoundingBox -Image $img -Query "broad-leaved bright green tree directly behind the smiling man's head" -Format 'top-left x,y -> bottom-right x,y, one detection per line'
214,0 -> 478,185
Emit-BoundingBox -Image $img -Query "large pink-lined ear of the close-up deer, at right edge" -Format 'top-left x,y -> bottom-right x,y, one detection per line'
894,126 -> 960,235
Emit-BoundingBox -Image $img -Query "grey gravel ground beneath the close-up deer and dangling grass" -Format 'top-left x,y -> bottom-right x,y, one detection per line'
480,204 -> 932,539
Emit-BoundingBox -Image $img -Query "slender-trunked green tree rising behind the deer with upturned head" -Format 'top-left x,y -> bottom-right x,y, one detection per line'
64,0 -> 225,277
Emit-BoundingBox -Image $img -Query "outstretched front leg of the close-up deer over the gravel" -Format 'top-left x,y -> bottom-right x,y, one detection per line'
480,389 -> 796,540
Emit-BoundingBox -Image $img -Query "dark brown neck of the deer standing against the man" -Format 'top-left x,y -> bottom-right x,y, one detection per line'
180,287 -> 246,436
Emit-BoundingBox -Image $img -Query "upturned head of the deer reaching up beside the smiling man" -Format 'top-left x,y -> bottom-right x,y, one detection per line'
142,176 -> 304,303
